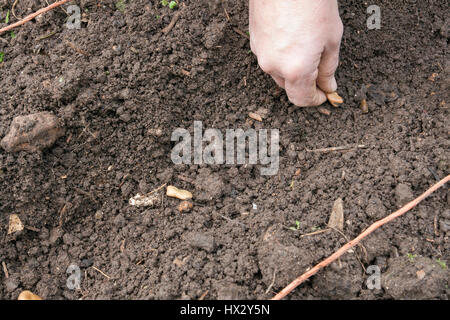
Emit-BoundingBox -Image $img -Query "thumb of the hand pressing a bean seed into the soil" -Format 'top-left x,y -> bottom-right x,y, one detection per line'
317,47 -> 339,93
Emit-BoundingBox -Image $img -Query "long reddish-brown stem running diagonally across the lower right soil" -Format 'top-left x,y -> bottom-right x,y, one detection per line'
272,175 -> 450,300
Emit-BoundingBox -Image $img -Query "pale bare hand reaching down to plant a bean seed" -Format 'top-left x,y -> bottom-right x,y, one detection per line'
249,0 -> 343,107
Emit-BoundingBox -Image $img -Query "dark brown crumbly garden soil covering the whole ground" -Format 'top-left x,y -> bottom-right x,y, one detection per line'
0,0 -> 450,299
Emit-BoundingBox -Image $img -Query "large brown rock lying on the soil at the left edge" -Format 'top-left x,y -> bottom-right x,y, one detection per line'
0,112 -> 64,152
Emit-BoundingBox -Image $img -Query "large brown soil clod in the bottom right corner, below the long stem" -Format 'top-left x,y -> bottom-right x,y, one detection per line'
381,256 -> 450,299
